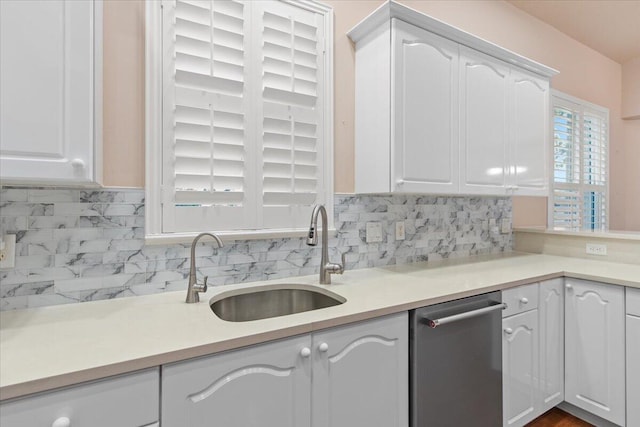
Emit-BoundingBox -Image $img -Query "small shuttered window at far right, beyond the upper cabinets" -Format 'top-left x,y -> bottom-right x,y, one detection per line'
549,91 -> 609,231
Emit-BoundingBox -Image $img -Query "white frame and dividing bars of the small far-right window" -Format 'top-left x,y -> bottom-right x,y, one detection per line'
547,89 -> 611,232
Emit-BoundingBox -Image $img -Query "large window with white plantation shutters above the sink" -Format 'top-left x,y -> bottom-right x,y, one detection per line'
146,0 -> 333,241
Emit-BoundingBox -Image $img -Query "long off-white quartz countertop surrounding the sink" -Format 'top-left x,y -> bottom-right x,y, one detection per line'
0,253 -> 640,400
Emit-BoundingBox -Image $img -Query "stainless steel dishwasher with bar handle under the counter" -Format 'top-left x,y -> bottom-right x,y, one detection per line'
409,292 -> 506,427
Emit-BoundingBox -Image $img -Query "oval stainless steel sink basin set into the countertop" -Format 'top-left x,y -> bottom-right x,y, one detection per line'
209,283 -> 346,322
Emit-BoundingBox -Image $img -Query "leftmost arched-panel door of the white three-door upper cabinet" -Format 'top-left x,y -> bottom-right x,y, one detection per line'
391,19 -> 459,193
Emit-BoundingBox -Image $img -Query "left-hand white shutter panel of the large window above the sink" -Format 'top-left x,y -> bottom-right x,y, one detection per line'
163,0 -> 255,231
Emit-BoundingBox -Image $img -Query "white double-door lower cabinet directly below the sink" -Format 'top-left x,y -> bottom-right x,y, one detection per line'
161,313 -> 408,427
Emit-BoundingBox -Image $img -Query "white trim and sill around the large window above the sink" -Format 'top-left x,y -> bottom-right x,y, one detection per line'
145,0 -> 335,244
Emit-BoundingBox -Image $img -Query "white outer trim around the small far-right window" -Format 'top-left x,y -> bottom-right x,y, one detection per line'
547,89 -> 611,233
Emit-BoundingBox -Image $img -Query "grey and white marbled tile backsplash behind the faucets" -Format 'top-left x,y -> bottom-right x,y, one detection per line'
0,187 -> 513,310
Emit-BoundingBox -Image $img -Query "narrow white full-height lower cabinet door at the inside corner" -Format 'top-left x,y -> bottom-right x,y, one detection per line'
538,279 -> 564,412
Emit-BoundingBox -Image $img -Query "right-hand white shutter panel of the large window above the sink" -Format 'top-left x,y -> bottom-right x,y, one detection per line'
254,2 -> 325,228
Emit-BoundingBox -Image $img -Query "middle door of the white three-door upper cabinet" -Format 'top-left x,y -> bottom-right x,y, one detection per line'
460,46 -> 509,194
